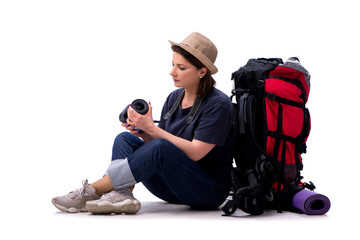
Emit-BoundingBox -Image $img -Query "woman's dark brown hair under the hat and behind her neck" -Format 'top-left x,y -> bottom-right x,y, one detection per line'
171,45 -> 216,96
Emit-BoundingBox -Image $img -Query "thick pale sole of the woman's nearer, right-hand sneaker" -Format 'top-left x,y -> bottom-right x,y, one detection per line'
86,199 -> 141,214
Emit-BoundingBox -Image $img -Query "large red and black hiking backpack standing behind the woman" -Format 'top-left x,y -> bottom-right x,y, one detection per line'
223,57 -> 315,215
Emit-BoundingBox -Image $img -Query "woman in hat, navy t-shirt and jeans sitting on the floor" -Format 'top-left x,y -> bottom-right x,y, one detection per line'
52,32 -> 233,213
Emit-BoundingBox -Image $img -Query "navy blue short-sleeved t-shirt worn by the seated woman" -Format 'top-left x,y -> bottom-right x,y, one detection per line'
158,88 -> 234,184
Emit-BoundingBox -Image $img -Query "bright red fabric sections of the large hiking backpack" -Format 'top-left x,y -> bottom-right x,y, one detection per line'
265,66 -> 310,181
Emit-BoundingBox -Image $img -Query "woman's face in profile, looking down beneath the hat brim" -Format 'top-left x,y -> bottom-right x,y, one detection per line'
170,52 -> 206,91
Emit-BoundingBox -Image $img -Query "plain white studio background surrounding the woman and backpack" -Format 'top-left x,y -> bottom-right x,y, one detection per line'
0,0 -> 360,239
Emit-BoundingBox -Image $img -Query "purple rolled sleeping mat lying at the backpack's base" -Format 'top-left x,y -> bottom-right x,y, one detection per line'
292,189 -> 331,215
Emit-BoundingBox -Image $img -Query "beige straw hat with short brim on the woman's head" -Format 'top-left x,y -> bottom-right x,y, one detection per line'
169,32 -> 218,74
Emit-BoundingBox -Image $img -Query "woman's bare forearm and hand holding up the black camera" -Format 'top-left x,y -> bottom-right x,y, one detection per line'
127,104 -> 215,161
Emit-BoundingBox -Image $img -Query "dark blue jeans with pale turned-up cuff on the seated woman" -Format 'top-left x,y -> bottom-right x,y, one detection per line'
107,132 -> 229,209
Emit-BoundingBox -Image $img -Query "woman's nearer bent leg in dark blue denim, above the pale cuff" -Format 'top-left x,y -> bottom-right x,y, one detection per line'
128,139 -> 230,208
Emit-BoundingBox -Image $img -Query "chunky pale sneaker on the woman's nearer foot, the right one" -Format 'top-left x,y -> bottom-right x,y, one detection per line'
86,188 -> 141,214
